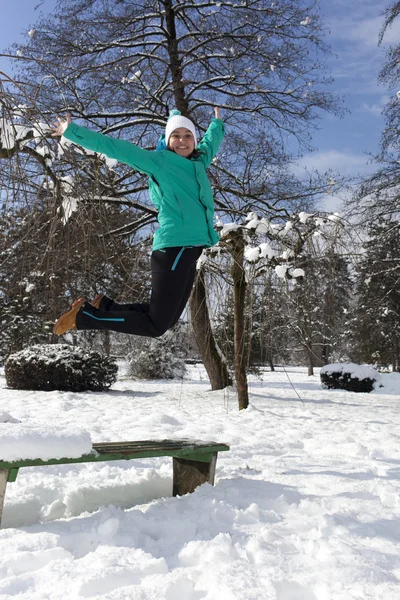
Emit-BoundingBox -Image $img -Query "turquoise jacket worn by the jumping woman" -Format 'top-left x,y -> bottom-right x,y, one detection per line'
64,119 -> 224,250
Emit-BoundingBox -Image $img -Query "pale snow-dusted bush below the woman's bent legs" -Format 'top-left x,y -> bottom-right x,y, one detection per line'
128,337 -> 186,379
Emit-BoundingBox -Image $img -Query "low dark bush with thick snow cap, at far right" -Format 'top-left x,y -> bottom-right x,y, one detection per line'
320,363 -> 380,392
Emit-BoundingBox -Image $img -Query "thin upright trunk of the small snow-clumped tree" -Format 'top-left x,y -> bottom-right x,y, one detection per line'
231,231 -> 249,410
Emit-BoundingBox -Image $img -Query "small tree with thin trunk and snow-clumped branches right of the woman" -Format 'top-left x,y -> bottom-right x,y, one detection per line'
199,211 -> 342,410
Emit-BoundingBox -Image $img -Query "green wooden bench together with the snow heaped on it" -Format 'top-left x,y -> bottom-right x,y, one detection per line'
0,413 -> 229,526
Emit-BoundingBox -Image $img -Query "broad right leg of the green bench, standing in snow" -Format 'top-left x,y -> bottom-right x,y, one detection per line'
172,452 -> 218,496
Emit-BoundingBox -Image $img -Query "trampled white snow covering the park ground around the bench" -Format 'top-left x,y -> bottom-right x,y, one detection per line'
0,367 -> 400,600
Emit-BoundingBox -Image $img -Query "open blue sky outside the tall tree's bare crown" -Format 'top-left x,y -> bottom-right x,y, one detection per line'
0,0 -> 400,204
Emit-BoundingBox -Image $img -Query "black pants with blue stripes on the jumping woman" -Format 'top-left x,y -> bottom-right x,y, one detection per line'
76,246 -> 203,337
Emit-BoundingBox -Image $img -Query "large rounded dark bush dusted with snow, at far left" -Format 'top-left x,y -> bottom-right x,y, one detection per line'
5,344 -> 118,392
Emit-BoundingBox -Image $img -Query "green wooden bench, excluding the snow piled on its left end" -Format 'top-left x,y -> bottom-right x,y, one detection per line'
0,440 -> 229,526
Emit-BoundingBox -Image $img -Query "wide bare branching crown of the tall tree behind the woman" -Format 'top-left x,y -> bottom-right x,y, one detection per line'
0,0 -> 338,390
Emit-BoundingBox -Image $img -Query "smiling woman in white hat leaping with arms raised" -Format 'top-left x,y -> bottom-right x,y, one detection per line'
52,108 -> 224,337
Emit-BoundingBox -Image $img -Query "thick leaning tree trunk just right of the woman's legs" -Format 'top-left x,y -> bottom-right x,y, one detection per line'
190,271 -> 232,390
